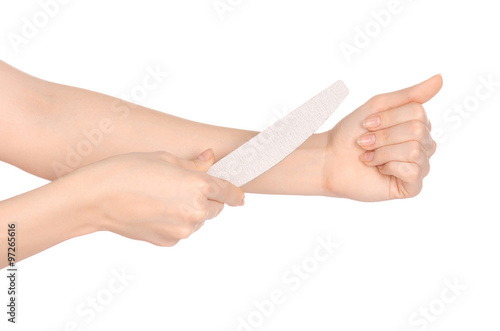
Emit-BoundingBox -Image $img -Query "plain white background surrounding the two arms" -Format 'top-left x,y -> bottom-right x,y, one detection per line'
0,0 -> 500,331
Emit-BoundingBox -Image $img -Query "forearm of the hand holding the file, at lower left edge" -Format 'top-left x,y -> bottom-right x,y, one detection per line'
0,178 -> 96,269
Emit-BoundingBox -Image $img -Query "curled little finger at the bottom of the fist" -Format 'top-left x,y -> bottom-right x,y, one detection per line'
378,161 -> 424,196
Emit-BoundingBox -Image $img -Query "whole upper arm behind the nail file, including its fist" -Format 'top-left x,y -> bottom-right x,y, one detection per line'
0,62 -> 442,201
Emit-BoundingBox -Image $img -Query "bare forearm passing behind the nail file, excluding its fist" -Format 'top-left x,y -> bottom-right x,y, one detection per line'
1,61 -> 326,194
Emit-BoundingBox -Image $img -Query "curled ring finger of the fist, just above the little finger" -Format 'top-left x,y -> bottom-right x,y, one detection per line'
360,142 -> 430,176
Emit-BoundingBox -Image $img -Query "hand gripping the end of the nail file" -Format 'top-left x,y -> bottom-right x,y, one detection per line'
65,150 -> 244,246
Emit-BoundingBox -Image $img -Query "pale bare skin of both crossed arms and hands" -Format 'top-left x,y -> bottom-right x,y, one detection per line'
0,61 -> 442,268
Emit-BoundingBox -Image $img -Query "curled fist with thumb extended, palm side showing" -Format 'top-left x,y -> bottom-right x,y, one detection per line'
323,75 -> 443,201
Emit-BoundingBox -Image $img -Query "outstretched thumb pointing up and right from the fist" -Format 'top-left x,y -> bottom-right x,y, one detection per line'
372,74 -> 443,108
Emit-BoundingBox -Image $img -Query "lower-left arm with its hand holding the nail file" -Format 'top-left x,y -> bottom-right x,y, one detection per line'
0,150 -> 244,269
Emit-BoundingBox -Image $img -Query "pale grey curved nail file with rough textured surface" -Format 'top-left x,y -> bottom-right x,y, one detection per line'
208,81 -> 349,186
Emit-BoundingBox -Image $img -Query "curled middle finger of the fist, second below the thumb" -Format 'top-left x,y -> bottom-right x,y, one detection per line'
357,120 -> 436,157
